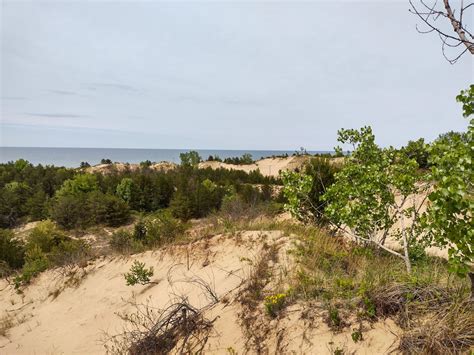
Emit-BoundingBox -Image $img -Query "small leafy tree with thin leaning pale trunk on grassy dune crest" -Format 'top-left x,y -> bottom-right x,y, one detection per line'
322,127 -> 427,272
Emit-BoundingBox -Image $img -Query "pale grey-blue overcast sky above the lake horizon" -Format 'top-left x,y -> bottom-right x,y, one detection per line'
0,0 -> 474,150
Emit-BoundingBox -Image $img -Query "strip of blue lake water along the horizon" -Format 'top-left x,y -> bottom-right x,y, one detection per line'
0,147 -> 324,167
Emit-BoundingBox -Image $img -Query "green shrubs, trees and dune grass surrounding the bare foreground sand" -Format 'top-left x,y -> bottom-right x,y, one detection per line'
0,86 -> 474,354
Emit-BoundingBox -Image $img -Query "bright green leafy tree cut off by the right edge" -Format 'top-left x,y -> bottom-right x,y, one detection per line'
427,85 -> 474,297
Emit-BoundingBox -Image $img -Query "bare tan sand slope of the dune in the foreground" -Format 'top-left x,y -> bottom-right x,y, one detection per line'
0,231 -> 398,354
